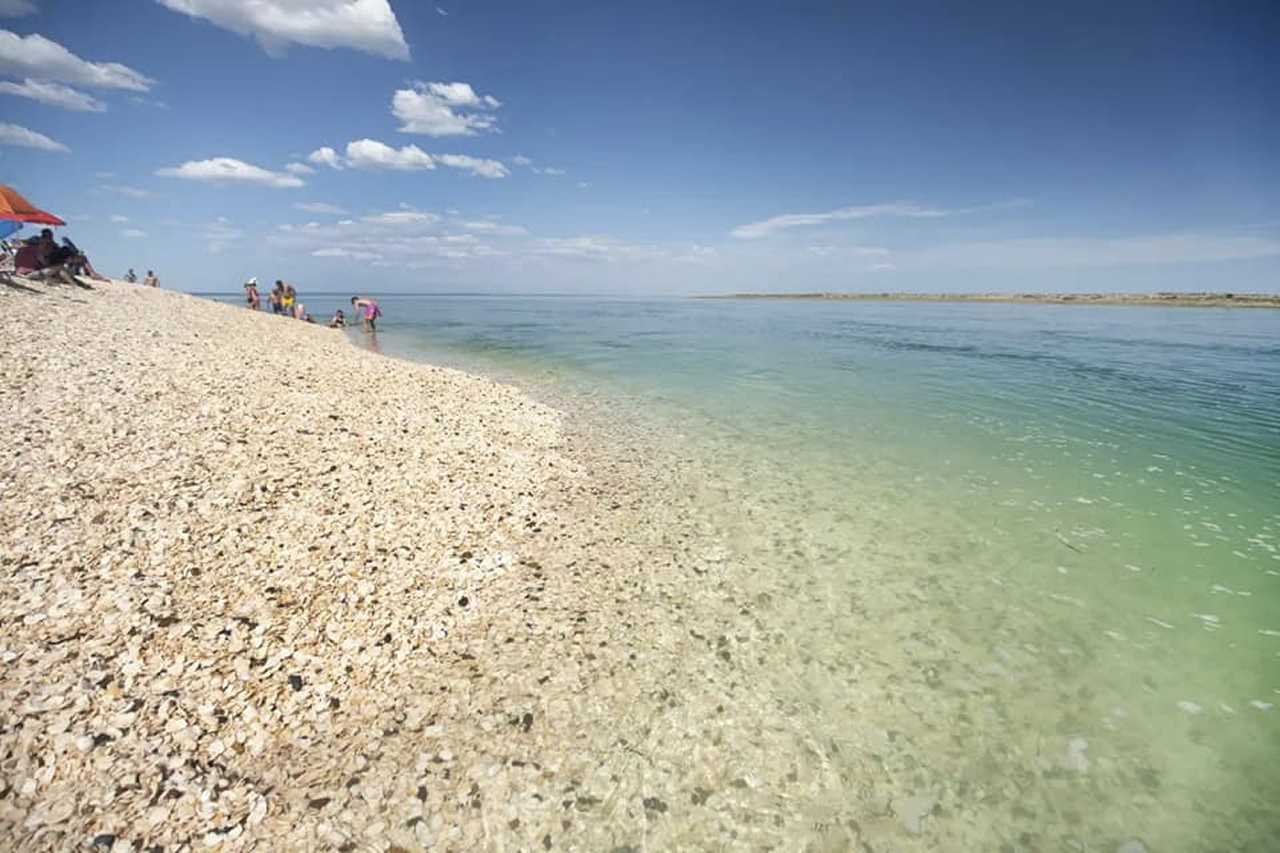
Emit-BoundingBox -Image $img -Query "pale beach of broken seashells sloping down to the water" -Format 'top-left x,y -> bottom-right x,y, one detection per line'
0,283 -> 799,849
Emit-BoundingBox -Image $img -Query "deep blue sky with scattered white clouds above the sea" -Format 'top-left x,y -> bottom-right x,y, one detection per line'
0,0 -> 1280,295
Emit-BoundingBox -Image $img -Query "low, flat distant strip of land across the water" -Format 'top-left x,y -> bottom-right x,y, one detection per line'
692,292 -> 1280,309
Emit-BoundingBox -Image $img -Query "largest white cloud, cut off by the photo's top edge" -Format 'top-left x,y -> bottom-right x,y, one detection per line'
159,0 -> 408,59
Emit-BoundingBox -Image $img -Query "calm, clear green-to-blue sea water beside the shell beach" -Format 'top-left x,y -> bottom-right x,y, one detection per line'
215,296 -> 1280,849
